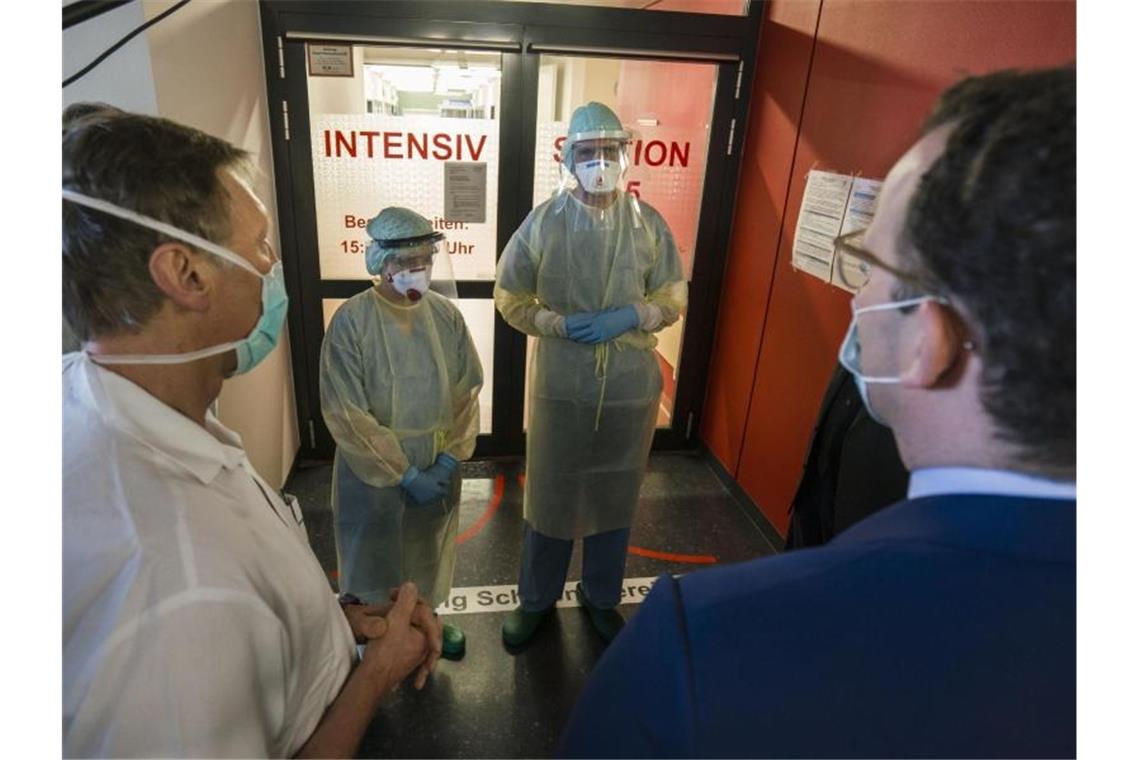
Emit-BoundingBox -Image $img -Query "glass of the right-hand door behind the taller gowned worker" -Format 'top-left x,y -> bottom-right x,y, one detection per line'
527,56 -> 717,427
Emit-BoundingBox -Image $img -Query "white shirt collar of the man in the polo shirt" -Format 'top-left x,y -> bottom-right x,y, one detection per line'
74,352 -> 245,483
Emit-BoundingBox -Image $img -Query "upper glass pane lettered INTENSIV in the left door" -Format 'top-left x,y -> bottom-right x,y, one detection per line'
307,46 -> 502,280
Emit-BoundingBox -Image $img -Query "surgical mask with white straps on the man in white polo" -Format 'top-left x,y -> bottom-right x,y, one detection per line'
63,190 -> 288,375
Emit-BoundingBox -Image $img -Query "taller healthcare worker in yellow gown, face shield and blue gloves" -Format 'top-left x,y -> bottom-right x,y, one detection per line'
495,103 -> 687,645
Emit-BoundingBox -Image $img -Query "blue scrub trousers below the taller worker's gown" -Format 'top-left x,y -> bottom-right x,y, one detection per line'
519,523 -> 629,612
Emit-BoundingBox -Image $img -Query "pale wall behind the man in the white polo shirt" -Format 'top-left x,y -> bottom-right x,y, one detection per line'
64,0 -> 300,487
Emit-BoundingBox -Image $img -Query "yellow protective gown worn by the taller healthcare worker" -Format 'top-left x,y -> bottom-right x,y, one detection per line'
495,190 -> 687,539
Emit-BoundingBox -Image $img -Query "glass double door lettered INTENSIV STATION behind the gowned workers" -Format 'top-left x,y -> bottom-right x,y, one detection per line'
278,19 -> 738,458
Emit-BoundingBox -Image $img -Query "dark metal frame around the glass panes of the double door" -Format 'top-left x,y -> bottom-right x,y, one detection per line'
261,0 -> 765,459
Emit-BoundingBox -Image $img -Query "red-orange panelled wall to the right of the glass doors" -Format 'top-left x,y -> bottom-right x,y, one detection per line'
701,0 -> 1076,532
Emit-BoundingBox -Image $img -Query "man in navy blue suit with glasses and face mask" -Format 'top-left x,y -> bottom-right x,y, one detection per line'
560,68 -> 1076,757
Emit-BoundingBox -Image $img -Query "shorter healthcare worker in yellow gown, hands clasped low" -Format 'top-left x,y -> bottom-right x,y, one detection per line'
320,206 -> 483,659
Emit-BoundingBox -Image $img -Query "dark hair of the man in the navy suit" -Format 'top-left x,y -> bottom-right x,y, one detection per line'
902,66 -> 1076,474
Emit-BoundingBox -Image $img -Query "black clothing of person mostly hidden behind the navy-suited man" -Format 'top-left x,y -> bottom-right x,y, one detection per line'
784,365 -> 910,549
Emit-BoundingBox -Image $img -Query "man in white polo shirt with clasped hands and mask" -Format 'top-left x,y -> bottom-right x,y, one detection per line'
63,106 -> 440,757
